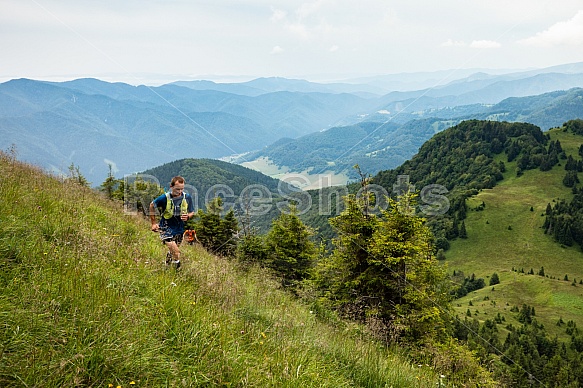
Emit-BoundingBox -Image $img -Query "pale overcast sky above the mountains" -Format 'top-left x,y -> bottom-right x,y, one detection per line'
0,0 -> 583,85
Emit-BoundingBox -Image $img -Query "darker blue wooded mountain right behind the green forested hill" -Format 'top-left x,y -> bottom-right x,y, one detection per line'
245,88 -> 583,179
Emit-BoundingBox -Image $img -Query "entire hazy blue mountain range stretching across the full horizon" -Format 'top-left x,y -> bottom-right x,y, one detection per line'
0,63 -> 583,185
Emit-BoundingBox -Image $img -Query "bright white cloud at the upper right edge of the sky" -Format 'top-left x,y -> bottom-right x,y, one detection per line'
518,10 -> 583,47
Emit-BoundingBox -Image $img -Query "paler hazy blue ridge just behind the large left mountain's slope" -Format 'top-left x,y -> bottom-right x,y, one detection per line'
56,79 -> 376,137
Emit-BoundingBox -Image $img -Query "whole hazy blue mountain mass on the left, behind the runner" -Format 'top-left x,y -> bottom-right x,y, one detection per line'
0,79 -> 374,185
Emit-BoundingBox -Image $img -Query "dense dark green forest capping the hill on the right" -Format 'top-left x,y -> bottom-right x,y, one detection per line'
373,120 -> 559,250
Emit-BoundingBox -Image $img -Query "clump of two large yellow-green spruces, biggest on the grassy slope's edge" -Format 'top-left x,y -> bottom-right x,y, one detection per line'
318,192 -> 449,339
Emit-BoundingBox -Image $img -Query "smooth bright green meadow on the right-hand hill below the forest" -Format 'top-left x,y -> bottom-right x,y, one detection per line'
446,129 -> 583,336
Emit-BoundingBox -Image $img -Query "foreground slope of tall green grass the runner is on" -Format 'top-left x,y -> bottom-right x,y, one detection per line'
0,154 -> 438,387
